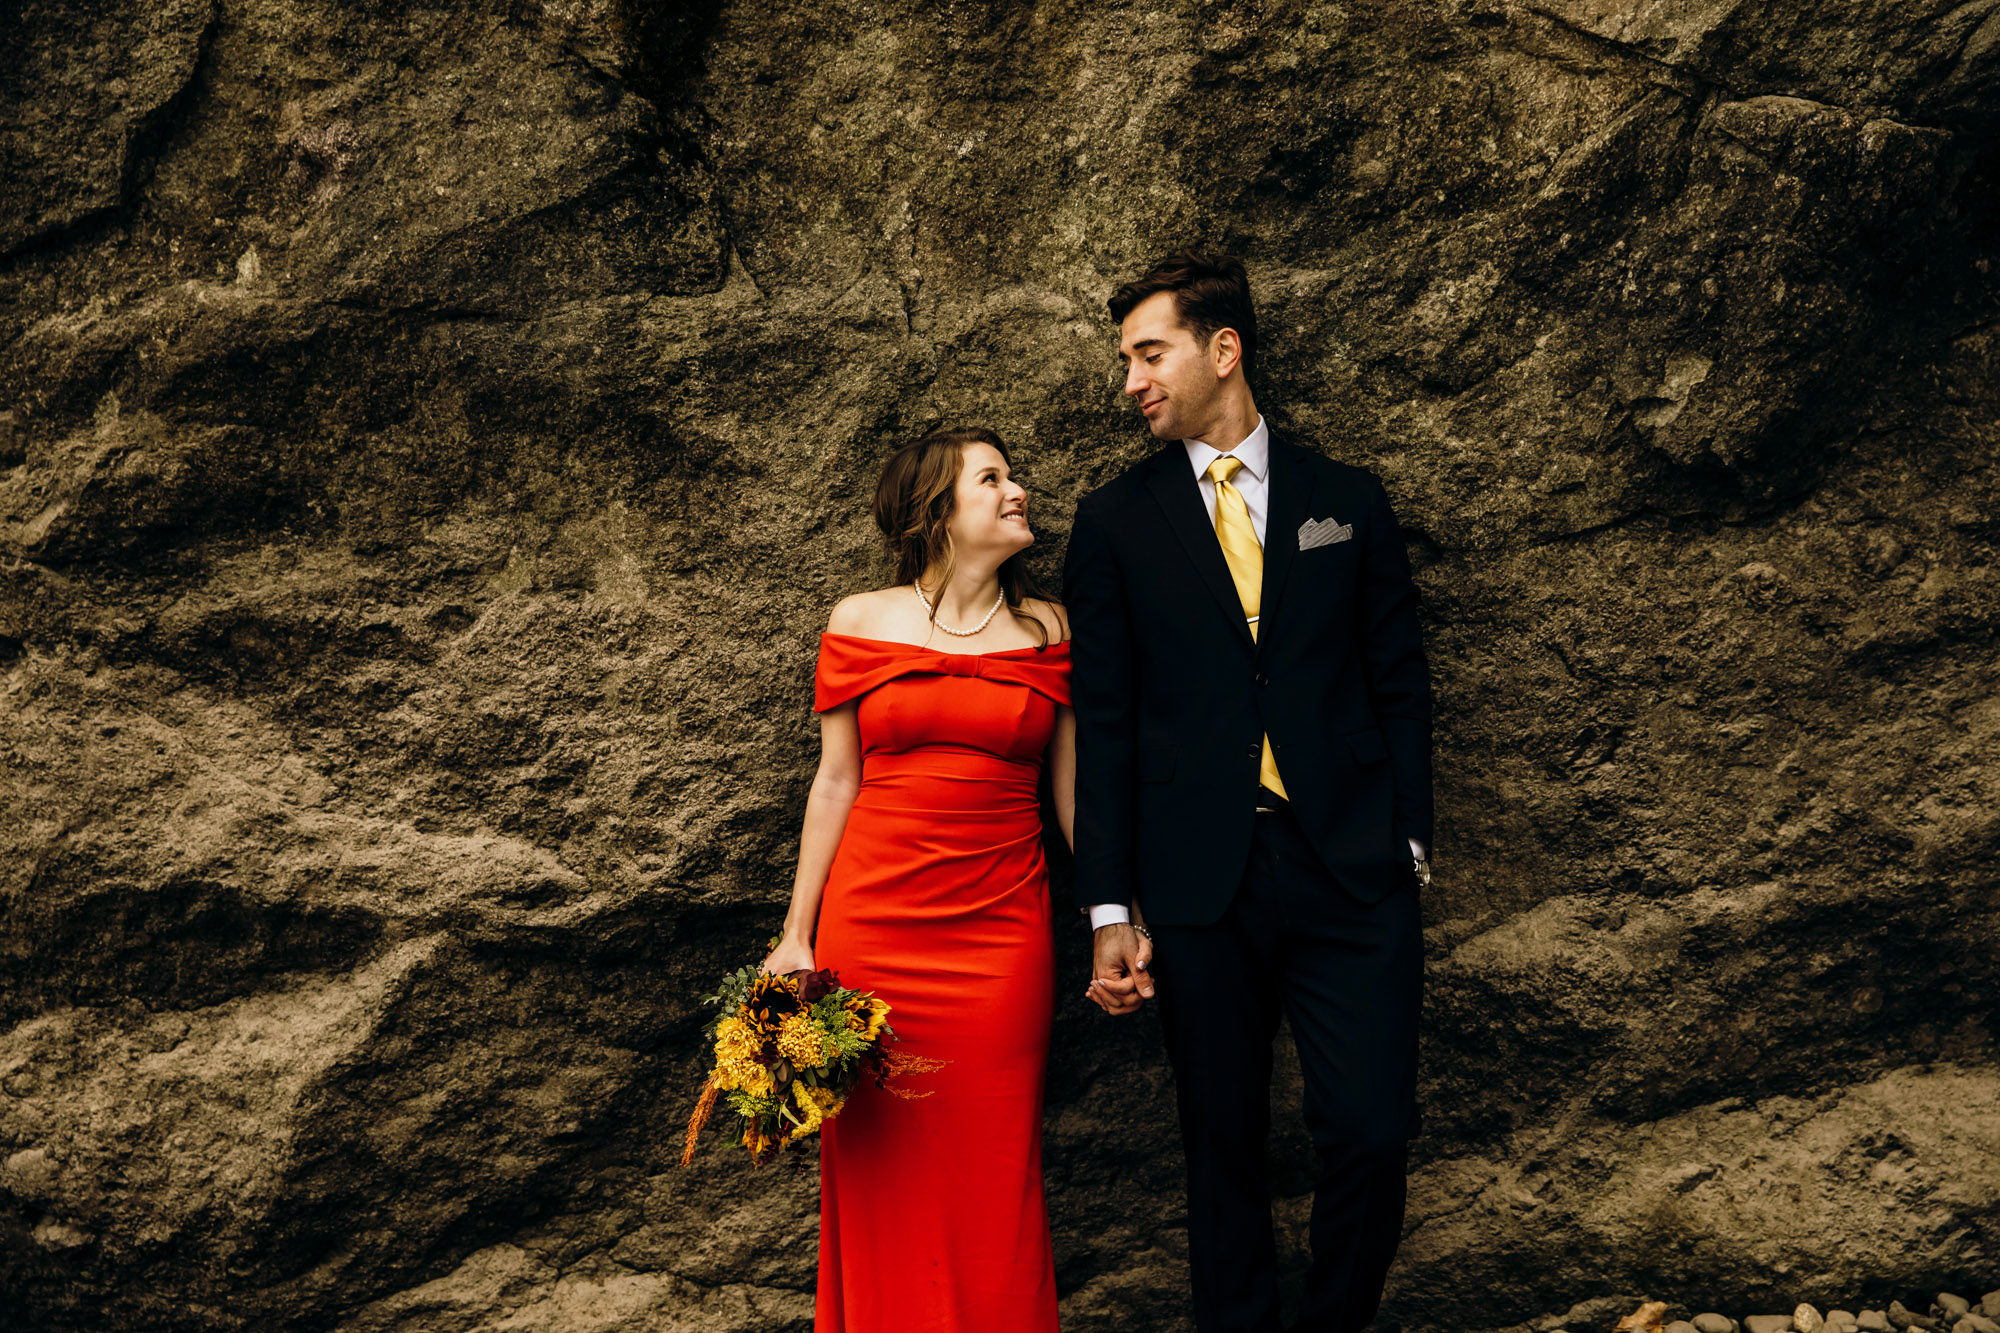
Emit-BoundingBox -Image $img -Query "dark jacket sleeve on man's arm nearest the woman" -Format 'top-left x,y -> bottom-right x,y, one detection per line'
1062,502 -> 1138,907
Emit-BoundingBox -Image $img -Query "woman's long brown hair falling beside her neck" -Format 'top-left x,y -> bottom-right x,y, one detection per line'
874,426 -> 1048,648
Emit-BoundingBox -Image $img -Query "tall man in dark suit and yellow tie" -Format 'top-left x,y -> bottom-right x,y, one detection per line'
1064,250 -> 1430,1333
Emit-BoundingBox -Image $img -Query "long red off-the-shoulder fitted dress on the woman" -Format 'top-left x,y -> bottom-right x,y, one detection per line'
812,634 -> 1070,1333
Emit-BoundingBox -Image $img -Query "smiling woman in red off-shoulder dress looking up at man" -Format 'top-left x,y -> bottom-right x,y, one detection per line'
764,430 -> 1076,1333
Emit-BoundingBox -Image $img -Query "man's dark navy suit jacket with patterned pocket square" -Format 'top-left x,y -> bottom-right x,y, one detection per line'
1062,434 -> 1432,925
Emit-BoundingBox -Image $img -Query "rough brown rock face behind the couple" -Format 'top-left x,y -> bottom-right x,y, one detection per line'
0,0 -> 2000,1333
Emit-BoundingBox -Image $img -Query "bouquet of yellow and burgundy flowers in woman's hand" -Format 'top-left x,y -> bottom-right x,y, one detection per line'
680,967 -> 944,1167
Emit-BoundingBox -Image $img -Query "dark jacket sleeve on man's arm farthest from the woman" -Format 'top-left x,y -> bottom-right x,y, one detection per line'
1360,476 -> 1432,847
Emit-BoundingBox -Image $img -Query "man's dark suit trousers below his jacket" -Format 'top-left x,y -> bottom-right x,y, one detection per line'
1152,809 -> 1424,1333
